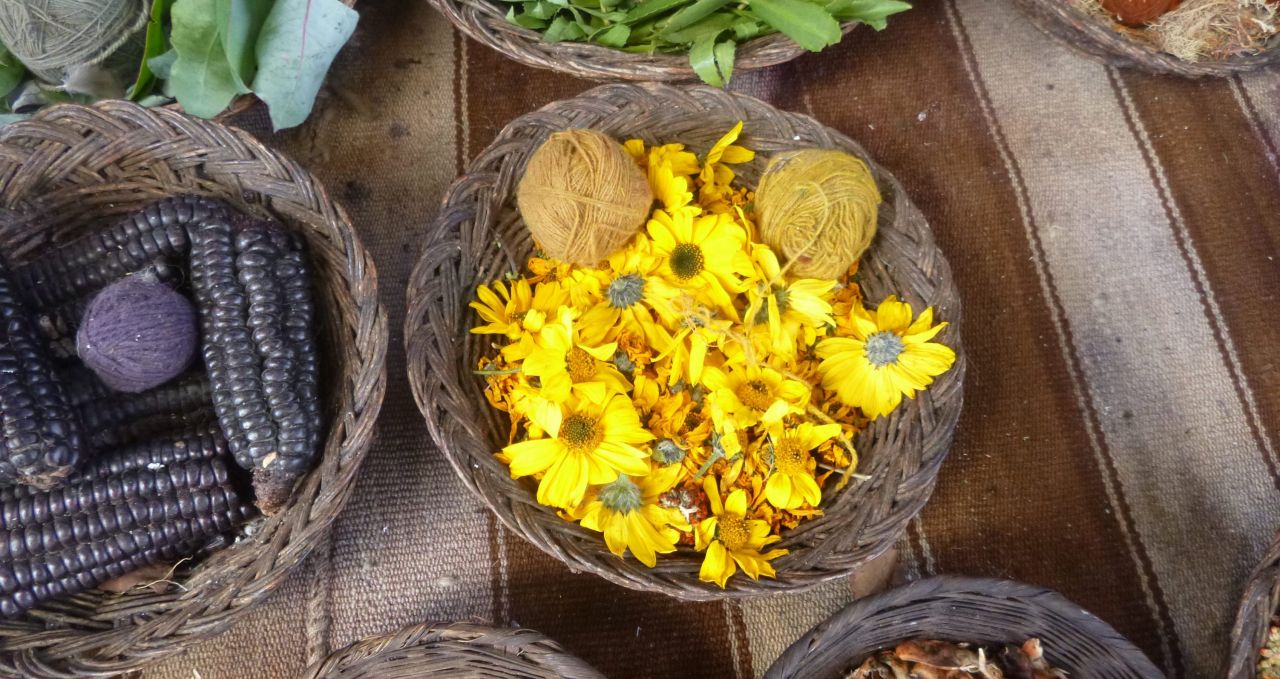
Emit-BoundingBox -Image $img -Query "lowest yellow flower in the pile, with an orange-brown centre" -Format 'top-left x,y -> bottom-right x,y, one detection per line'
695,477 -> 787,588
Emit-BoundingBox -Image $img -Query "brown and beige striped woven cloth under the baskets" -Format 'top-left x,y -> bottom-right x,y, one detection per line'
145,0 -> 1280,679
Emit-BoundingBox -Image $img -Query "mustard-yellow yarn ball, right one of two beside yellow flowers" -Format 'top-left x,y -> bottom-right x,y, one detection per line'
755,149 -> 881,279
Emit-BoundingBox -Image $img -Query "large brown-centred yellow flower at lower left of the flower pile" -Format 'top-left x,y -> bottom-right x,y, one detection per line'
500,395 -> 653,509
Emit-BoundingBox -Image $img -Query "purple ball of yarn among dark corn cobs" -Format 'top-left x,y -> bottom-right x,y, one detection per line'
76,277 -> 197,392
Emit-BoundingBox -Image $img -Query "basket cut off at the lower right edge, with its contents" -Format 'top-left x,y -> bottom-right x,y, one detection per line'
1228,527 -> 1280,679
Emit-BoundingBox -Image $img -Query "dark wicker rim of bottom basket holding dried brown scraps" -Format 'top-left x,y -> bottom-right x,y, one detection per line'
764,577 -> 1164,679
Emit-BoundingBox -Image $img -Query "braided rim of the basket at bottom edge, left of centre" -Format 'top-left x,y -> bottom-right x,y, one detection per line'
301,621 -> 604,679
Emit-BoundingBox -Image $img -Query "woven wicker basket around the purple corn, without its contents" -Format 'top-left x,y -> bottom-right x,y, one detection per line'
0,101 -> 387,676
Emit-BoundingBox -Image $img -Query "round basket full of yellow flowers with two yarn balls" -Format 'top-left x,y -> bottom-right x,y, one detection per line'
406,85 -> 964,600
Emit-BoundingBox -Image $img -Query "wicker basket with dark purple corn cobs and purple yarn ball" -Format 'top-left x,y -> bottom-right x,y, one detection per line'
0,101 -> 387,676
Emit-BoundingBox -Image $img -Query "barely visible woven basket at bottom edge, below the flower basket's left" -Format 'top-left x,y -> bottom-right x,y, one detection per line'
302,623 -> 604,679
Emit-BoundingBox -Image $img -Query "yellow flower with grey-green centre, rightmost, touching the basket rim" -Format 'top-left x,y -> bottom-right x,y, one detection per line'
817,296 -> 956,418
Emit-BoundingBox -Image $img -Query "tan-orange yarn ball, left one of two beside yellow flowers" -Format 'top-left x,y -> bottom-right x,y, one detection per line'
516,129 -> 653,266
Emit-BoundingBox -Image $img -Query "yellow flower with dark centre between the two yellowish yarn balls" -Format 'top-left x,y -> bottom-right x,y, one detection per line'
648,208 -> 751,320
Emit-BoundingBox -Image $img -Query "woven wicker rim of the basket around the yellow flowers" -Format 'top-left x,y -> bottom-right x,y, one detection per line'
404,83 -> 965,601
